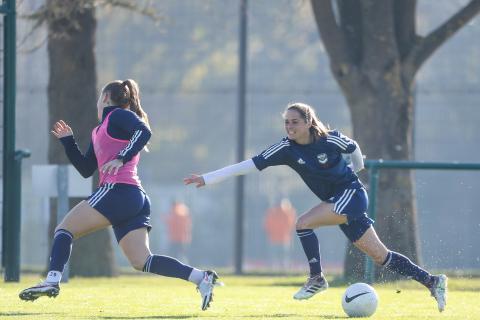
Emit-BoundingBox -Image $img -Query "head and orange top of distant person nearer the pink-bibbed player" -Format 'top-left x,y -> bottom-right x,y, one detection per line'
166,201 -> 192,244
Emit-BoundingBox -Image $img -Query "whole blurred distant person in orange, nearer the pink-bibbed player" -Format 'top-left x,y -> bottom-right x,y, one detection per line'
166,201 -> 192,261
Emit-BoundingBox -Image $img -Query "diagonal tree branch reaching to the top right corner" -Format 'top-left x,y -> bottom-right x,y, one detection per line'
407,0 -> 480,77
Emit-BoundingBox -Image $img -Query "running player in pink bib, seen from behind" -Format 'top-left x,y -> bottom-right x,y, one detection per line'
20,79 -> 218,310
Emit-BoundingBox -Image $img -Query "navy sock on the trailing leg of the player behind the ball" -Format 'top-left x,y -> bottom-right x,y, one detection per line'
382,251 -> 433,288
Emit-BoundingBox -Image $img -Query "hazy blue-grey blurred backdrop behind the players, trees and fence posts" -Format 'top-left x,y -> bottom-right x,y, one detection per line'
9,0 -> 480,273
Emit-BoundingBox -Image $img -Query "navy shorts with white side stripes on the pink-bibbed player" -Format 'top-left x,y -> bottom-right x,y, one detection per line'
87,183 -> 152,242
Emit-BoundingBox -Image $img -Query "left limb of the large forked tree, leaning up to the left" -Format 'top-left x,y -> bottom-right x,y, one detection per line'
310,0 -> 352,76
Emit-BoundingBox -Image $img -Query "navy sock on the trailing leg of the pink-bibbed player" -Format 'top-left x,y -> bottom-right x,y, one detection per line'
143,254 -> 193,281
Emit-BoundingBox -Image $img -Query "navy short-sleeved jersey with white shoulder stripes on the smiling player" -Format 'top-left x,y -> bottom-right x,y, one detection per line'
252,130 -> 362,201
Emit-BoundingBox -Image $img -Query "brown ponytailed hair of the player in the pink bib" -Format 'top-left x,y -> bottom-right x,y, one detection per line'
102,79 -> 150,128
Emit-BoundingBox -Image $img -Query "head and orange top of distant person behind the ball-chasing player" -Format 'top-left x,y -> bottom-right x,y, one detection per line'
264,199 -> 297,245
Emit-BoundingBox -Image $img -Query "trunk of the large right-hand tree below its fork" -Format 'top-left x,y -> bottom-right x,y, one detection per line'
342,67 -> 420,280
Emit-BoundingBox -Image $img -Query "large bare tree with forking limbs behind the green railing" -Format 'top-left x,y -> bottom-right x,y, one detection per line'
311,0 -> 480,279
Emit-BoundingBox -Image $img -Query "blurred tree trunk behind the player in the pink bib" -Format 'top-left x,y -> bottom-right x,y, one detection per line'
47,0 -> 115,276
